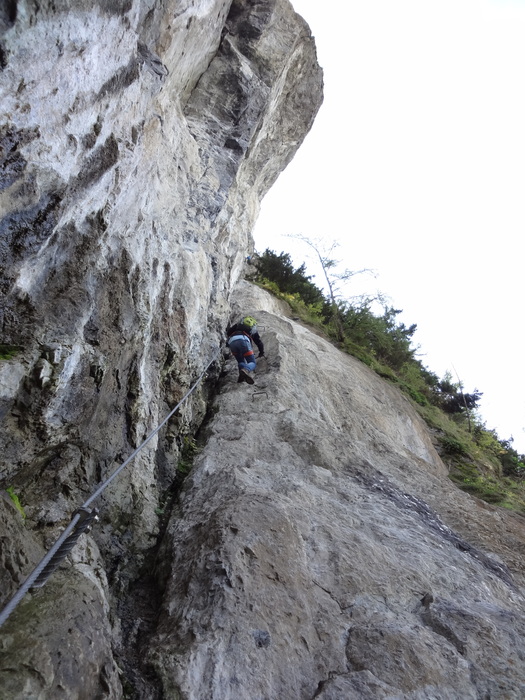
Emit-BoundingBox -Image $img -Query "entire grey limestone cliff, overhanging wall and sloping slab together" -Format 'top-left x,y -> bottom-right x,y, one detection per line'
0,0 -> 525,700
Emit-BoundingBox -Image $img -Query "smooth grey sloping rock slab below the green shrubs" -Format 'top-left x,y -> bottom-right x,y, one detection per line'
147,284 -> 525,700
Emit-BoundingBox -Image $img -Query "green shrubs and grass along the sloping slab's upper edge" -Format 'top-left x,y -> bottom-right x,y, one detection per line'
254,249 -> 525,512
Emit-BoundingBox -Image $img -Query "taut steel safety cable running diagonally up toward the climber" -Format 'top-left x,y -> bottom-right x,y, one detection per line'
0,349 -> 220,627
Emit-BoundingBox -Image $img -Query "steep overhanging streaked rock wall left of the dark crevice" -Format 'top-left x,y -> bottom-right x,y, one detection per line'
0,0 -> 322,698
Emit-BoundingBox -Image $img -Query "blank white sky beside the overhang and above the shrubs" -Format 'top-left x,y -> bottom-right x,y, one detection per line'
254,0 -> 525,453
